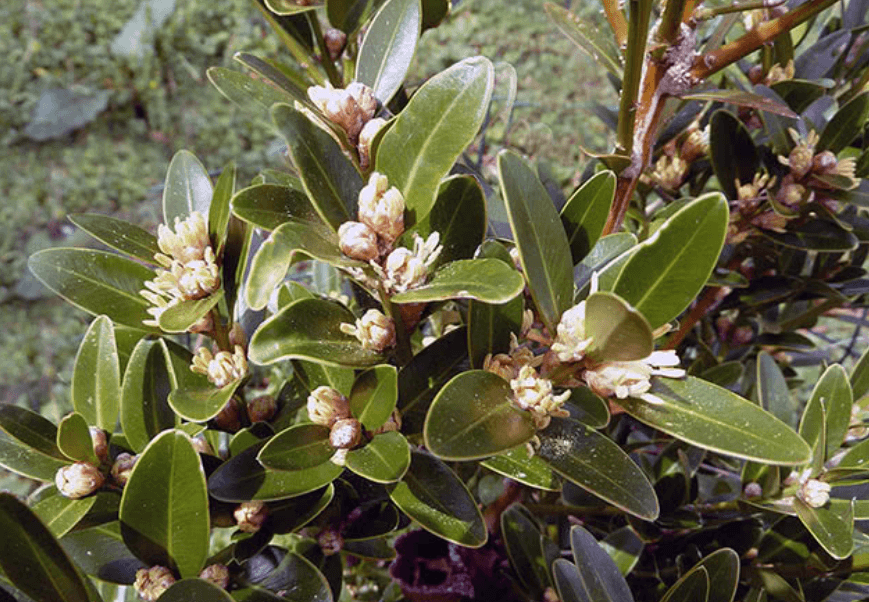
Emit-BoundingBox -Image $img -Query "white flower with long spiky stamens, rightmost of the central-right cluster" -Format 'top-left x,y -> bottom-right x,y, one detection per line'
582,350 -> 685,404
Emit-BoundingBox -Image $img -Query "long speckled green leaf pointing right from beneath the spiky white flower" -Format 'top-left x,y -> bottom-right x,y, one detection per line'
618,376 -> 811,466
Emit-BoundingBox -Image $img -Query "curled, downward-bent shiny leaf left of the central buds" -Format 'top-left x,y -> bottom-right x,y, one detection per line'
247,222 -> 365,309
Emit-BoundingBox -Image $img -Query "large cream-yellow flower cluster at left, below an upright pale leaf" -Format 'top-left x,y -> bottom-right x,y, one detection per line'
140,211 -> 220,332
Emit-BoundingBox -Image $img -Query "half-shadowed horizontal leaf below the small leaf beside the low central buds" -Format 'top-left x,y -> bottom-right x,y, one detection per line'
208,442 -> 342,502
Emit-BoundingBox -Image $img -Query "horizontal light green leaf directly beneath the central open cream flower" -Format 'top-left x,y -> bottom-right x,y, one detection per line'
392,259 -> 525,303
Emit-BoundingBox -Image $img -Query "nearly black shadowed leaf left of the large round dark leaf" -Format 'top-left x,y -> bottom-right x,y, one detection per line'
398,328 -> 468,435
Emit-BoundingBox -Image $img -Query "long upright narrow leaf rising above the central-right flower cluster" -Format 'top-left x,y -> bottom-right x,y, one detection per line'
498,151 -> 573,332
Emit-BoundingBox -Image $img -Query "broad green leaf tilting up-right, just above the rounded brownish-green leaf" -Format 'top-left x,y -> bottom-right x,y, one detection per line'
612,193 -> 728,329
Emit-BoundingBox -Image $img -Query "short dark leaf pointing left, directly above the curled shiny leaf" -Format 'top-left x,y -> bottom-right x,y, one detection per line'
232,184 -> 323,230
